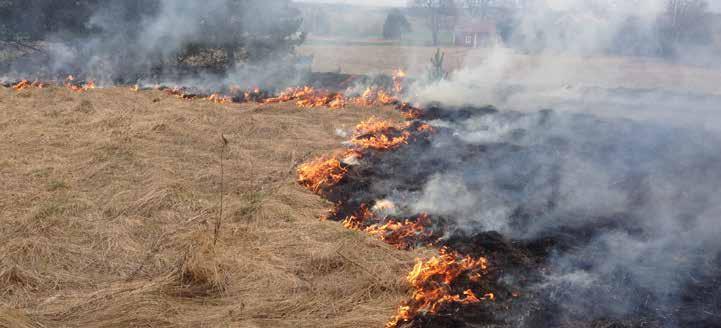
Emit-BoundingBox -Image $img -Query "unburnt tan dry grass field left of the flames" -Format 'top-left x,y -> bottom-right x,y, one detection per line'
0,87 -> 421,328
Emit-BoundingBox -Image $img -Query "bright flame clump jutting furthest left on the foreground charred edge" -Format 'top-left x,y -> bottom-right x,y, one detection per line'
298,150 -> 362,194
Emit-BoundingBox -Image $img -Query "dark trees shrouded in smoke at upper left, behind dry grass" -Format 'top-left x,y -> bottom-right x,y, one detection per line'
0,0 -> 304,75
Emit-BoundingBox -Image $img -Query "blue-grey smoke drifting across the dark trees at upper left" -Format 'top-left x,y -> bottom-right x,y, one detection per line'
6,0 -> 302,89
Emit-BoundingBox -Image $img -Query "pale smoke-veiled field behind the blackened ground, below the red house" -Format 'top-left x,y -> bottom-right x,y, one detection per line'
300,44 -> 721,131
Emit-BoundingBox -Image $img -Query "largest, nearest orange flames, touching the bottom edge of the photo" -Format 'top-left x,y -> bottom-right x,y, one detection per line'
386,248 -> 495,328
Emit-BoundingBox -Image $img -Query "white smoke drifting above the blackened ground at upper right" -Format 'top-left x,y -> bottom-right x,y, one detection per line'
409,0 -> 721,130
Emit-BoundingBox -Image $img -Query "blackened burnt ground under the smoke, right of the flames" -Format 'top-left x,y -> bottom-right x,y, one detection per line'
318,106 -> 721,328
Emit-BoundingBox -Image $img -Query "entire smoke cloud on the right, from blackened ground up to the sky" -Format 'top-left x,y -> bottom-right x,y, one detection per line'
371,0 -> 721,327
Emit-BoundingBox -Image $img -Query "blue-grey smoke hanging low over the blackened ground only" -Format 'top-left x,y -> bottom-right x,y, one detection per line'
363,108 -> 721,327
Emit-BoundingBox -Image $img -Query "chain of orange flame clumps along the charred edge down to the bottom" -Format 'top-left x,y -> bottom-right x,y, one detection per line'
298,100 -> 495,328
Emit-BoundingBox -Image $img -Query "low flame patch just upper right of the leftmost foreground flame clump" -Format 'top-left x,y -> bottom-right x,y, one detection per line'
351,117 -> 411,150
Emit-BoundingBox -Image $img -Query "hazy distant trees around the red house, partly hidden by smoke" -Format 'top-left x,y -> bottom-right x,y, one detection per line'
384,0 -> 714,56
